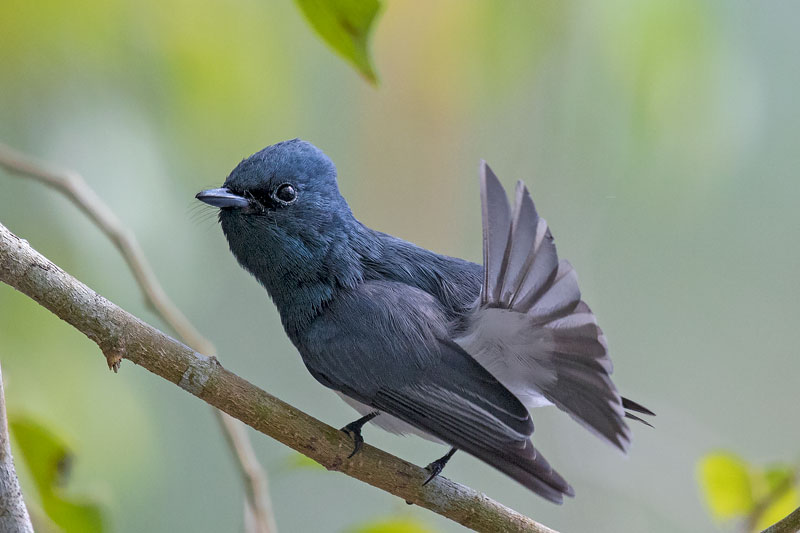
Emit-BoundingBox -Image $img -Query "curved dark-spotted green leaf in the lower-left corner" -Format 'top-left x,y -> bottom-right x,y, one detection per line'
8,416 -> 104,533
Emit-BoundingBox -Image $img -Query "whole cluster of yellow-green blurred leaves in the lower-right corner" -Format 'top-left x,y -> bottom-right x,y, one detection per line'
698,451 -> 800,531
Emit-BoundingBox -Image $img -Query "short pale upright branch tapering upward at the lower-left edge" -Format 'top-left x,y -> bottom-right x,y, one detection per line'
0,360 -> 33,533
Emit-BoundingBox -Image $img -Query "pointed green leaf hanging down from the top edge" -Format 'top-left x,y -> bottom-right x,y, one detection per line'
295,0 -> 381,85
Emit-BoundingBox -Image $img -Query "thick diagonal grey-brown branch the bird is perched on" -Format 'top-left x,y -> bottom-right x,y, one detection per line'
0,218 -> 554,533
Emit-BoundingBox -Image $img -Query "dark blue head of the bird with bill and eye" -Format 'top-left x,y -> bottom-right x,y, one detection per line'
196,139 -> 354,312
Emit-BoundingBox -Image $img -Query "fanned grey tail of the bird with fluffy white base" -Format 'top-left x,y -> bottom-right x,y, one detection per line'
456,162 -> 630,451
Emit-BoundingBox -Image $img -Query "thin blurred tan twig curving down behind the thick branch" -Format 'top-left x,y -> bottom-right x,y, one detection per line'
0,143 -> 277,533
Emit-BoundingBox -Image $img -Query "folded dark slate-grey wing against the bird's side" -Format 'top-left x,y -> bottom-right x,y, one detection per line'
300,282 -> 573,503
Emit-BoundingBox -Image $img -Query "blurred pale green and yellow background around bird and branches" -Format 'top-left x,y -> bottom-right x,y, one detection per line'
0,0 -> 800,532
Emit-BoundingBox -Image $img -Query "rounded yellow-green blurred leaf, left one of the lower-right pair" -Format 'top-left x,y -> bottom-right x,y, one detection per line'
698,452 -> 755,520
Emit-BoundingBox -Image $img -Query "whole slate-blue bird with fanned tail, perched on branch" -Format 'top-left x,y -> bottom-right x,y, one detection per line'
196,139 -> 653,504
